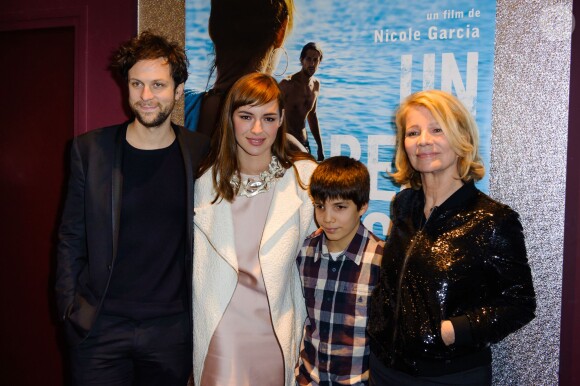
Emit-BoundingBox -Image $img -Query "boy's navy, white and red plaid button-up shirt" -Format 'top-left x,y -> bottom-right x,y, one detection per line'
296,224 -> 385,385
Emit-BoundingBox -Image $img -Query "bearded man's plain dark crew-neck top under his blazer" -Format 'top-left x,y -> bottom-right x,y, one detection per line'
103,137 -> 186,319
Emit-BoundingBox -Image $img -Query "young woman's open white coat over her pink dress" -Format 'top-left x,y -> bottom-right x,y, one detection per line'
193,161 -> 317,386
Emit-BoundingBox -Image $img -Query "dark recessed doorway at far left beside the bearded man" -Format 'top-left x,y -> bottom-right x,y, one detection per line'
0,27 -> 75,385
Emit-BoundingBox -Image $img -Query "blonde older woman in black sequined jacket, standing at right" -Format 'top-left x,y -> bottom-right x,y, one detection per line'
368,90 -> 536,386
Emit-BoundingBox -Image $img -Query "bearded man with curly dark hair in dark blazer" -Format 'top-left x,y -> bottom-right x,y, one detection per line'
56,32 -> 209,386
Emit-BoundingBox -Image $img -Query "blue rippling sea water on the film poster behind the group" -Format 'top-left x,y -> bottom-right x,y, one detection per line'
186,0 -> 496,237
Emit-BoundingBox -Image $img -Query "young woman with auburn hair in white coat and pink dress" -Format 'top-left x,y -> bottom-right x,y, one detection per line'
193,73 -> 316,386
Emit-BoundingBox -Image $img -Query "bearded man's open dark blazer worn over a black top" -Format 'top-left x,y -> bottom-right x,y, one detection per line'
55,122 -> 209,345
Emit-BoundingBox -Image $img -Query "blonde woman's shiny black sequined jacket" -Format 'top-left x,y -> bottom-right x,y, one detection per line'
368,183 -> 536,375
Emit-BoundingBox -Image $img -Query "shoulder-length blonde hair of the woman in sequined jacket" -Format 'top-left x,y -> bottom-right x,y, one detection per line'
391,90 -> 485,189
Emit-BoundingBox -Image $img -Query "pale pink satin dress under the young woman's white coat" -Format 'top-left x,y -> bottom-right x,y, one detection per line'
201,185 -> 284,386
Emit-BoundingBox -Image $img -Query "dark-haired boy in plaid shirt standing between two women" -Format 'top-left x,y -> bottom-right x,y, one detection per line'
296,156 -> 385,385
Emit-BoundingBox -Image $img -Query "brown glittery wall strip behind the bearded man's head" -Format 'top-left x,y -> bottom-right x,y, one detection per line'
137,0 -> 185,125
